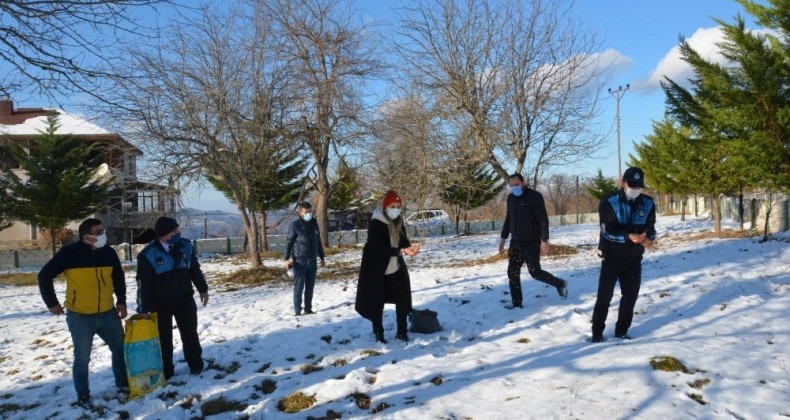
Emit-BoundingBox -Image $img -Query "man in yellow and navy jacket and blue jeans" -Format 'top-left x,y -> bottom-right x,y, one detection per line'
38,219 -> 128,405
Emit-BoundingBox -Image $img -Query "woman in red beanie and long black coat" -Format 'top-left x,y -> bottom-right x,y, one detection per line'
354,190 -> 420,343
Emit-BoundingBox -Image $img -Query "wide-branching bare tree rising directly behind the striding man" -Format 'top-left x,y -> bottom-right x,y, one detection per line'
397,0 -> 603,187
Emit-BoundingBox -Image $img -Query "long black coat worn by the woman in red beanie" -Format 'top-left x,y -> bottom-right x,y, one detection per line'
354,215 -> 411,320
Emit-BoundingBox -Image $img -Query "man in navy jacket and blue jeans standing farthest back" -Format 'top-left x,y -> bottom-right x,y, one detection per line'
285,201 -> 325,316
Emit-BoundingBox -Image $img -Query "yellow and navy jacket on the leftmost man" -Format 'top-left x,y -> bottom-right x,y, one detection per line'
38,241 -> 126,314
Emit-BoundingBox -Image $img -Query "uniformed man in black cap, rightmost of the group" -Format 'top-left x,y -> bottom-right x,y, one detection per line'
592,168 -> 656,343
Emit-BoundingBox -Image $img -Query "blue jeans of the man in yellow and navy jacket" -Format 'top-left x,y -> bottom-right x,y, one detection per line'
66,309 -> 129,398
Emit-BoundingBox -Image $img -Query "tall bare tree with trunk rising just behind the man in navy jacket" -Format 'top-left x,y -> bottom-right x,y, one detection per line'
255,0 -> 381,246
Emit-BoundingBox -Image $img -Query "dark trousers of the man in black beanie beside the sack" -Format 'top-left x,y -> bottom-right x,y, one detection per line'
157,295 -> 203,379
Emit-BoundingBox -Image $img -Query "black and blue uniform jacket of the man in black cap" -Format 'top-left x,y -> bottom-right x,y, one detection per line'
598,189 -> 656,258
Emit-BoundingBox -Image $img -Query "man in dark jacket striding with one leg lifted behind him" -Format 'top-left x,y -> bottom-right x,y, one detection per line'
499,174 -> 568,308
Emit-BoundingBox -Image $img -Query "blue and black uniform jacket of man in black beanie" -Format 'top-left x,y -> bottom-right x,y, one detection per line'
137,239 -> 208,312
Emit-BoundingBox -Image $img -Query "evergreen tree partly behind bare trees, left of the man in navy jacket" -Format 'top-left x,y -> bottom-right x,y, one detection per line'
207,147 -> 307,251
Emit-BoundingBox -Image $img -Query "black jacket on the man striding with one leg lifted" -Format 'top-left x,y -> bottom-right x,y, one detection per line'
500,187 -> 549,244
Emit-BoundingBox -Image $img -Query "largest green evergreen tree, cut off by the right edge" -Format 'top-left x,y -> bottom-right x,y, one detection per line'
662,0 -> 790,233
